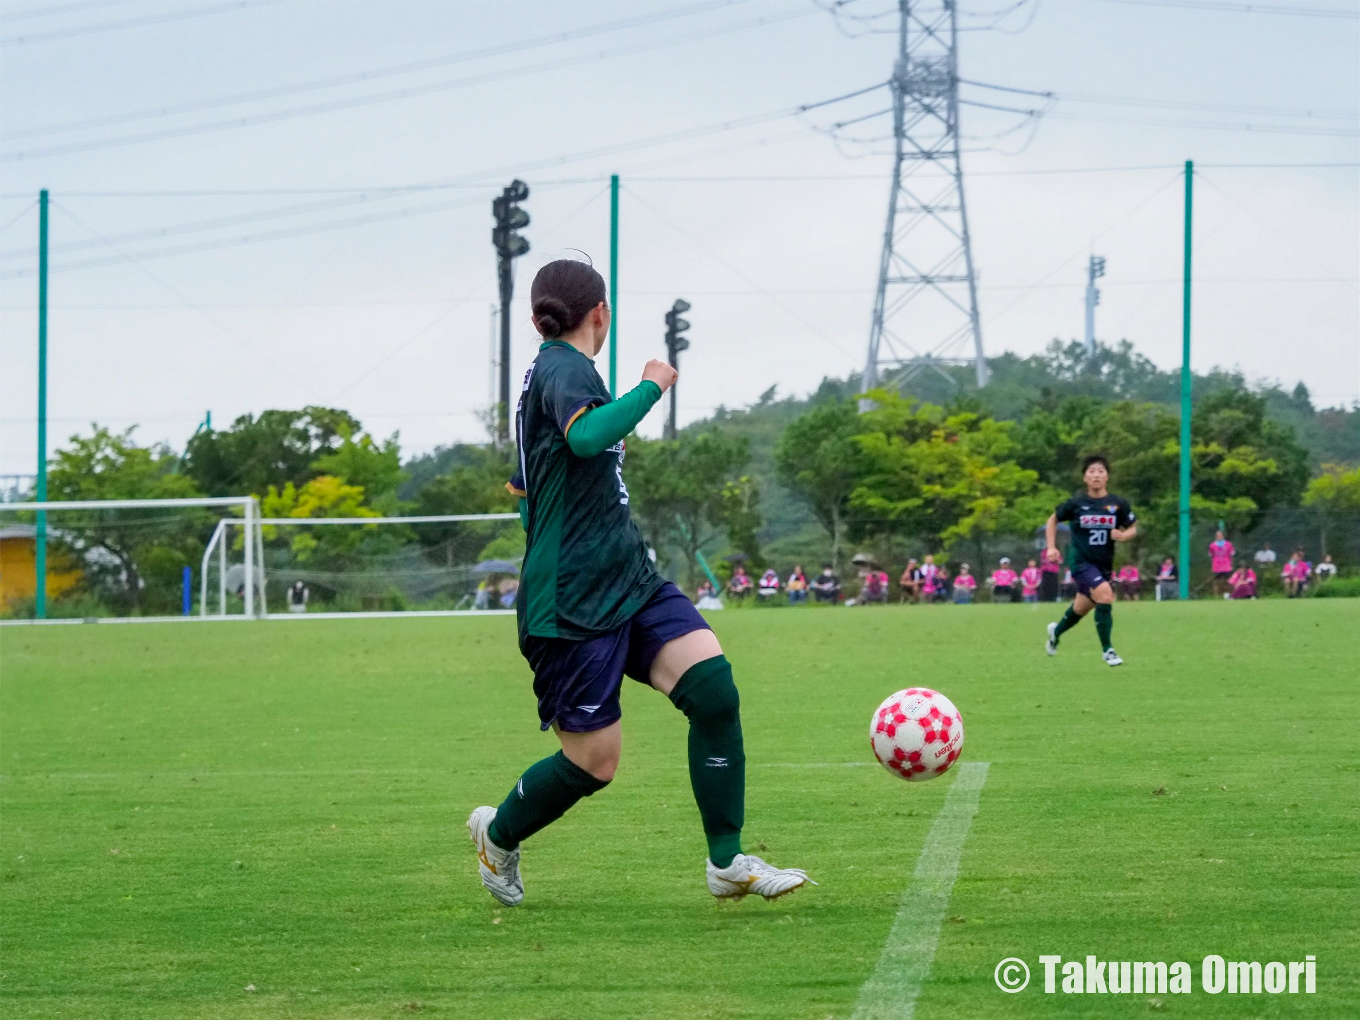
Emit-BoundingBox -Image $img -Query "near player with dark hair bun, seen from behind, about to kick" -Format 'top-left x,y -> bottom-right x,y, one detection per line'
468,260 -> 815,907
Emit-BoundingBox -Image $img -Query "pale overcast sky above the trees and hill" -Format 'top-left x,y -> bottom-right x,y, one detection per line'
0,0 -> 1360,473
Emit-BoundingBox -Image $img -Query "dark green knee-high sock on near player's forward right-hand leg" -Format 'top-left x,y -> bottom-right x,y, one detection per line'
670,656 -> 747,868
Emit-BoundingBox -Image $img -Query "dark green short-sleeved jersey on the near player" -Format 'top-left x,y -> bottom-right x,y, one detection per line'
511,340 -> 665,646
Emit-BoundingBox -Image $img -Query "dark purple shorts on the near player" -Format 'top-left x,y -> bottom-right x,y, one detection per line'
524,582 -> 709,733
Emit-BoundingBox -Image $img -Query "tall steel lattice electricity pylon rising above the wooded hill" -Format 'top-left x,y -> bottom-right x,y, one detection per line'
860,0 -> 987,409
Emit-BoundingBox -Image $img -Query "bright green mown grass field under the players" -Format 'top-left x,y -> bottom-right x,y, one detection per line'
0,600 -> 1360,1020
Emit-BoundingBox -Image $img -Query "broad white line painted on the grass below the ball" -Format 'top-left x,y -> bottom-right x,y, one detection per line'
851,762 -> 989,1020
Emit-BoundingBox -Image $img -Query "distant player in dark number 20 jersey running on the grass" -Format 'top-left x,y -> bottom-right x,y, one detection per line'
1044,454 -> 1138,666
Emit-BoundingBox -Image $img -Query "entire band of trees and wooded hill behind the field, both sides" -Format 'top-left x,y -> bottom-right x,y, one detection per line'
21,343 -> 1360,612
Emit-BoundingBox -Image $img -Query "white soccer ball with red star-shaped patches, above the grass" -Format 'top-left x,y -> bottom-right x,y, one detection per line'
869,687 -> 963,782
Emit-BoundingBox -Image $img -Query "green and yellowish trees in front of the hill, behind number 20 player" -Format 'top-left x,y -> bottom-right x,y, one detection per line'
775,390 -> 1360,576
